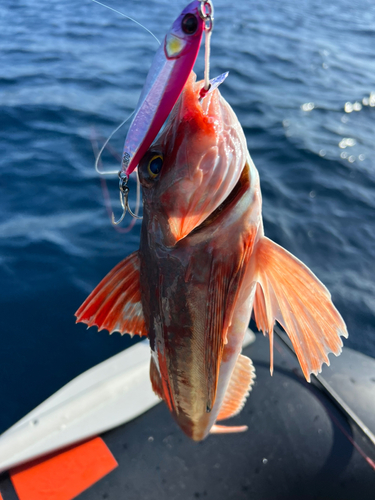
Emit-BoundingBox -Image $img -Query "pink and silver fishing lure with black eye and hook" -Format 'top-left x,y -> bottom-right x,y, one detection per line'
112,0 -> 214,225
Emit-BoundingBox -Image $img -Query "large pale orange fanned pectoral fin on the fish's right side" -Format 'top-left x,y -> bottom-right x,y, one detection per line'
254,237 -> 348,381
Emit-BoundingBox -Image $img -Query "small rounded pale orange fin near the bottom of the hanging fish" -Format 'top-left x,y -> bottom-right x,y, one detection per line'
217,354 -> 255,420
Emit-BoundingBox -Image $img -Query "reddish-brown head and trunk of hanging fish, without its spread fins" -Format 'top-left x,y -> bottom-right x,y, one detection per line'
139,73 -> 261,440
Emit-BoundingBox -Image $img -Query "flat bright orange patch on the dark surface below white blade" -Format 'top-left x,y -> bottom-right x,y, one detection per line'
9,438 -> 118,500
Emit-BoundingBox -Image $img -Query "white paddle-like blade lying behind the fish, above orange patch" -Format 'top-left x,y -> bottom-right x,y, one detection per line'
0,330 -> 254,472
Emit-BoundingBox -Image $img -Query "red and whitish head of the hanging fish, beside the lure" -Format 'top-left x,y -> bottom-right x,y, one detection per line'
138,72 -> 247,246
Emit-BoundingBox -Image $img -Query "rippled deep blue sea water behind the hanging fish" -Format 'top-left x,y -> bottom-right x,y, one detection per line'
0,0 -> 375,432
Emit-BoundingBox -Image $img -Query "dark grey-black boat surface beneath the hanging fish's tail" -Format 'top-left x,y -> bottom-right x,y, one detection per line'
0,336 -> 375,500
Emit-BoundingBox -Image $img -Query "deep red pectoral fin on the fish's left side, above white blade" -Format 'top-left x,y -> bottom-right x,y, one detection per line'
75,252 -> 147,337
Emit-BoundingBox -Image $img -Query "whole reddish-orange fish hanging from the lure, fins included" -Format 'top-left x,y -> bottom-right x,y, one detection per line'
76,74 -> 347,441
